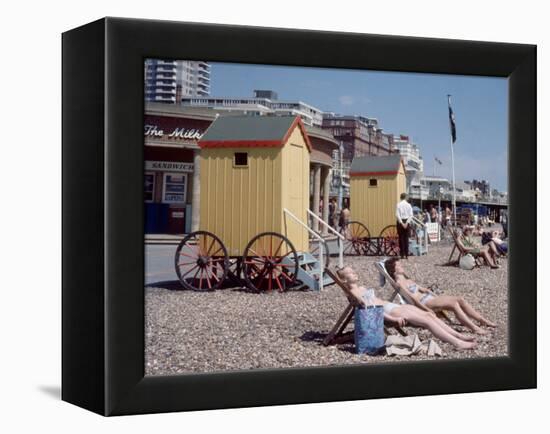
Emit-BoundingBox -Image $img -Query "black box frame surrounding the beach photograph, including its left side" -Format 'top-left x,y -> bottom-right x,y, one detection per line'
62,18 -> 536,415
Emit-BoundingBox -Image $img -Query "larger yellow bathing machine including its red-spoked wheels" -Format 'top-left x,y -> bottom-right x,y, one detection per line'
175,116 -> 326,291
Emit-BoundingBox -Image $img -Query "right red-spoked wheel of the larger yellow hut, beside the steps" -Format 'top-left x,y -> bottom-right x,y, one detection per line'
242,232 -> 299,292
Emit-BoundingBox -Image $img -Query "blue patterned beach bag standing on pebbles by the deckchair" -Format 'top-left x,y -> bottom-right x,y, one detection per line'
354,292 -> 385,355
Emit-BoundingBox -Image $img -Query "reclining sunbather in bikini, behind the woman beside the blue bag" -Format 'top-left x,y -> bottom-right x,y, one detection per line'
384,258 -> 496,335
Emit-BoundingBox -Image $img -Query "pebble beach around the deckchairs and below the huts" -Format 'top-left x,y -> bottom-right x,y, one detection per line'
145,234 -> 508,375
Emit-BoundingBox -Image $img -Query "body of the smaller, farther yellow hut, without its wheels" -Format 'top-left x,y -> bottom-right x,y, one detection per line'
350,155 -> 406,236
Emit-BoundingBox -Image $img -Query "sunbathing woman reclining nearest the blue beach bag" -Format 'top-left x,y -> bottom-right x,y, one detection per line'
337,267 -> 477,350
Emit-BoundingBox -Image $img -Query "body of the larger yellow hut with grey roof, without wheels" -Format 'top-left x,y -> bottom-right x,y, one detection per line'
199,116 -> 311,256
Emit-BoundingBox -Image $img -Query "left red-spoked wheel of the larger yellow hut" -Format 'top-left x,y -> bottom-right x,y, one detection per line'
175,231 -> 229,291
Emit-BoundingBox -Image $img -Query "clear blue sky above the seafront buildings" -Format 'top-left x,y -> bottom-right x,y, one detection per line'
210,63 -> 508,191
